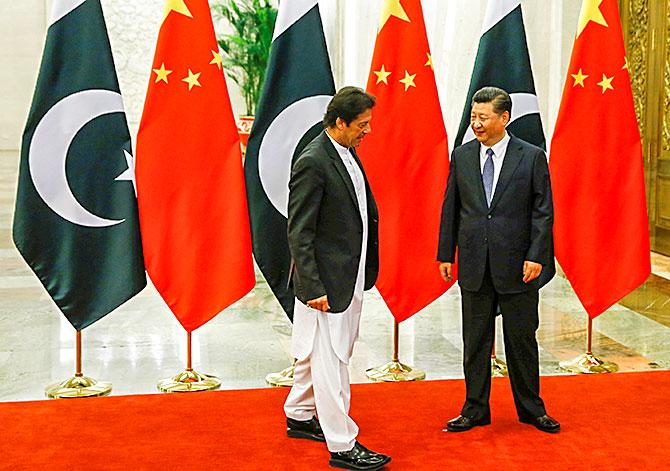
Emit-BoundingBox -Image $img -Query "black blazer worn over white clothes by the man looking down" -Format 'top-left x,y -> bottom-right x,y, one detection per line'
288,131 -> 379,312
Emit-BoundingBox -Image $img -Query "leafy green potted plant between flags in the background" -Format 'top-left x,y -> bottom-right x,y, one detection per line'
210,0 -> 277,148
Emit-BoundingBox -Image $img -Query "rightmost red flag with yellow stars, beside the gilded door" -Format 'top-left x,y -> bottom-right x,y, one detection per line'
549,0 -> 651,318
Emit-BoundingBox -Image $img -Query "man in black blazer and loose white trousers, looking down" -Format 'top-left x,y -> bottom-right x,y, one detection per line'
284,87 -> 391,470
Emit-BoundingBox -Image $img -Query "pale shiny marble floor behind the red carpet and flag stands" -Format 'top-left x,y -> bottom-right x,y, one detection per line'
0,152 -> 670,401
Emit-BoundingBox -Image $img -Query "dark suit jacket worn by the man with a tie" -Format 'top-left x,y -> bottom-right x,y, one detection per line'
437,136 -> 556,294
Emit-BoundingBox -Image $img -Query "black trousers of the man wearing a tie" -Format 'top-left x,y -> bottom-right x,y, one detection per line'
461,264 -> 546,420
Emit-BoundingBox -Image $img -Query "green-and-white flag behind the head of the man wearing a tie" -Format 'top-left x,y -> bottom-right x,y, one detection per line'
456,0 -> 545,149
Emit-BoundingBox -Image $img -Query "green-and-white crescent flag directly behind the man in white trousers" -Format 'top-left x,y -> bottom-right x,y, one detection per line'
244,0 -> 335,318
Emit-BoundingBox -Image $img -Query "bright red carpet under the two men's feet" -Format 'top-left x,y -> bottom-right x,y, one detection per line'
0,371 -> 670,471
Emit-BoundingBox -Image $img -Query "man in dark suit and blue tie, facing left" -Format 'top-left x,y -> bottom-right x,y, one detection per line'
437,87 -> 560,432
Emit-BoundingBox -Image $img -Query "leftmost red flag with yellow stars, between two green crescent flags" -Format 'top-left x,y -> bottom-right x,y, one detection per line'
136,0 -> 255,332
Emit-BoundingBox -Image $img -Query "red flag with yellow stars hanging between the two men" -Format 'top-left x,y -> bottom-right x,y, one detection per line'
361,0 -> 450,322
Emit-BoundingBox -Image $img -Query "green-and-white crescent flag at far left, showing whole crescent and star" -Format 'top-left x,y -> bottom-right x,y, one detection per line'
13,0 -> 146,330
